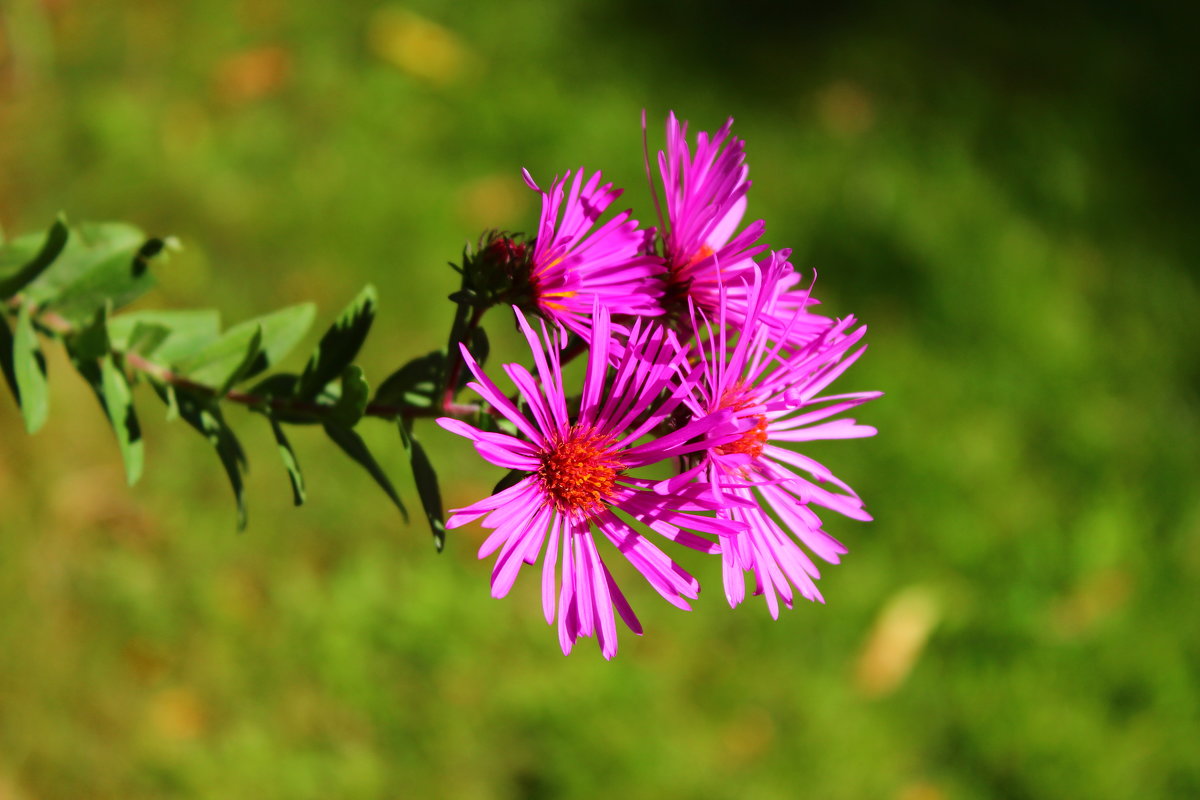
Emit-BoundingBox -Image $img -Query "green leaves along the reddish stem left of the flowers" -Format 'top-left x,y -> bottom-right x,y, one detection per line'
0,218 -> 451,549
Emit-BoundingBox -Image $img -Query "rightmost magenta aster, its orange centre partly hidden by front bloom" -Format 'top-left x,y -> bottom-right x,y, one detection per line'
681,258 -> 882,618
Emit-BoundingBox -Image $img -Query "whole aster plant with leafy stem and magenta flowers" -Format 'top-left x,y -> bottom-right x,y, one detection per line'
0,114 -> 880,658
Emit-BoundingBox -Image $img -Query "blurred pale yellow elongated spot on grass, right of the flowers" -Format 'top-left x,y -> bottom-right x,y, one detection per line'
854,587 -> 941,697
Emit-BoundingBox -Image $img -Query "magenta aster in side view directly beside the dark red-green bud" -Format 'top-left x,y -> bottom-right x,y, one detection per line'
513,168 -> 664,338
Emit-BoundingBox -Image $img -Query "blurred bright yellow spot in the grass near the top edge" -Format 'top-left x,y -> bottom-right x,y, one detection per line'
367,7 -> 468,86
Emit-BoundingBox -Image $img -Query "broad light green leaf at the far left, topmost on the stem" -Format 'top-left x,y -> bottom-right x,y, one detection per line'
25,223 -> 154,323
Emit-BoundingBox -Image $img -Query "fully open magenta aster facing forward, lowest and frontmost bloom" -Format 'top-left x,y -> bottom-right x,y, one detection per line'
438,303 -> 743,658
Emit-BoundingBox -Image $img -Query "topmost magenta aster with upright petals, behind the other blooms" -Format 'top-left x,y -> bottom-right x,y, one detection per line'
642,113 -> 830,344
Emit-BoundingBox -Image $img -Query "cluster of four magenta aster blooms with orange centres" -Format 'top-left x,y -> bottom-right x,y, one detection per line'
439,114 -> 880,658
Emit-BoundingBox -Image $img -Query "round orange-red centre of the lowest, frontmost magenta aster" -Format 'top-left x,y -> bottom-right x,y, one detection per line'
538,428 -> 625,517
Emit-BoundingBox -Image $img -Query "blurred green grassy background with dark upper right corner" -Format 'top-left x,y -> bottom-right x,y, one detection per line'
0,0 -> 1200,800
